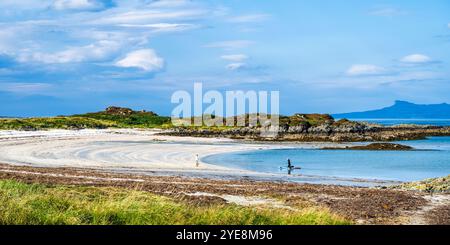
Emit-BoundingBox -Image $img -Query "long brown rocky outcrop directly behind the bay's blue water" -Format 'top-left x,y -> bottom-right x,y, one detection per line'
164,122 -> 450,142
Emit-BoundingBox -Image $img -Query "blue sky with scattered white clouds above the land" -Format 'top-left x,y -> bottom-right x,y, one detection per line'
0,0 -> 450,116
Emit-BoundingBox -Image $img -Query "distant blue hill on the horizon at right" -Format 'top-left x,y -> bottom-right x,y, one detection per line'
333,100 -> 450,119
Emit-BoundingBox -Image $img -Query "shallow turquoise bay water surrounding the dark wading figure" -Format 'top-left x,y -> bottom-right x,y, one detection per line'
202,137 -> 450,181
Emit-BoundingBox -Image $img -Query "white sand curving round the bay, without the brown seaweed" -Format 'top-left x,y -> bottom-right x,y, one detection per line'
0,129 -> 401,186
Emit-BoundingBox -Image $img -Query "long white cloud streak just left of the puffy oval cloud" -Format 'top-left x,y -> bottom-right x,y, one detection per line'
18,40 -> 120,64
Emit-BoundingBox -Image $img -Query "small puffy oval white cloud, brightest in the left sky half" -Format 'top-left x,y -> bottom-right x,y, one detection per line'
116,49 -> 164,71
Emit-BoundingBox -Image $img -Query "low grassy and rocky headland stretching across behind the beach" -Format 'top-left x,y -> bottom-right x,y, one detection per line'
0,103 -> 450,142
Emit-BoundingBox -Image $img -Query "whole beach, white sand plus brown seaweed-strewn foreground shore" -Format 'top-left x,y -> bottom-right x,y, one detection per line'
0,129 -> 449,224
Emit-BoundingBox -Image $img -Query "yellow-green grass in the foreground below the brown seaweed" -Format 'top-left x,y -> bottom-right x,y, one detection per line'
0,180 -> 350,225
